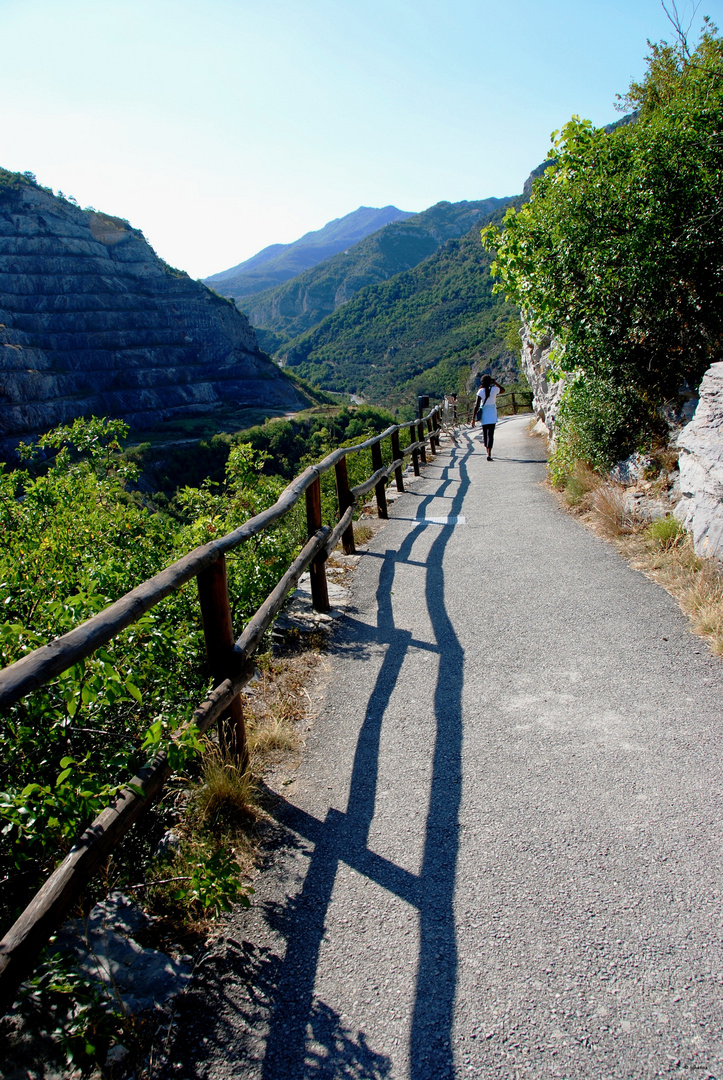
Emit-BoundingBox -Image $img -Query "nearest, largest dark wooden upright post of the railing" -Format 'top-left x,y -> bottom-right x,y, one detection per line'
196,555 -> 249,772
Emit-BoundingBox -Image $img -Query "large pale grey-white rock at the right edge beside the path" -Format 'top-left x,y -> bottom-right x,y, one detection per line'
675,362 -> 723,558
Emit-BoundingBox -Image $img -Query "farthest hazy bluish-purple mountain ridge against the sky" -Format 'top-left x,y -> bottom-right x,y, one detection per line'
204,206 -> 412,308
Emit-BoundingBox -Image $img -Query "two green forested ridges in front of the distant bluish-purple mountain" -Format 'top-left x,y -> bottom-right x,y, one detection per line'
202,195 -> 522,405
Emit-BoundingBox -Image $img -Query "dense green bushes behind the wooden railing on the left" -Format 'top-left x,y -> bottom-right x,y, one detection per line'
0,409 -> 391,933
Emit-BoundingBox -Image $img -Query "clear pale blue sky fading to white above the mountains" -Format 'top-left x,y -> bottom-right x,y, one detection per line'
0,0 -> 723,278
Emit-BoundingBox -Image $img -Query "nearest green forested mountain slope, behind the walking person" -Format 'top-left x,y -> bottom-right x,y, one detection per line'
284,198 -> 520,405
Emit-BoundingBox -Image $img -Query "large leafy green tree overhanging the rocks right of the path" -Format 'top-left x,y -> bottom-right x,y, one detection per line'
483,24 -> 723,474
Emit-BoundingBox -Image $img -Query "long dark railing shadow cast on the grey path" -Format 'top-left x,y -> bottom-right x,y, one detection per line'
263,447 -> 473,1080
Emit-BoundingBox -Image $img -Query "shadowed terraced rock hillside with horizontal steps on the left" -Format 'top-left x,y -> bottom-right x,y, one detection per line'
0,172 -> 305,445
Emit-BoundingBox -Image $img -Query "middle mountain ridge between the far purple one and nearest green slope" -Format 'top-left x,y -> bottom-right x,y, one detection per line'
234,199 -> 509,352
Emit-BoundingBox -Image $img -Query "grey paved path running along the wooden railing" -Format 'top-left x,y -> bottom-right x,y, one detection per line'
166,419 -> 723,1080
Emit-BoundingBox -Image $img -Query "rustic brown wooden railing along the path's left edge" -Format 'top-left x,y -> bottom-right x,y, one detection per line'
0,406 -> 440,1013
